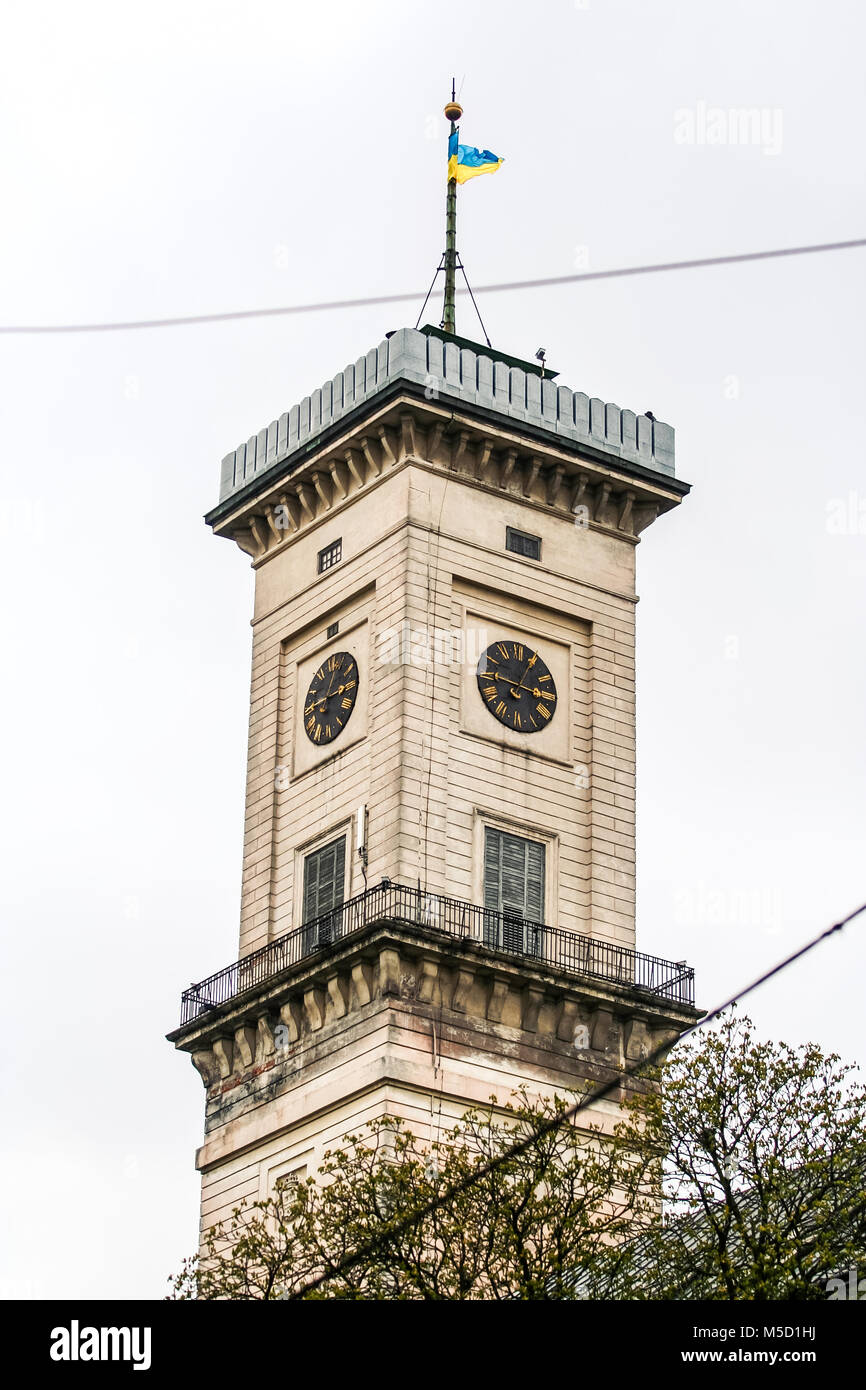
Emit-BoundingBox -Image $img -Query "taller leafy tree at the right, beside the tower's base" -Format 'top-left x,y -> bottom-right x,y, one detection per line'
608,1012 -> 866,1301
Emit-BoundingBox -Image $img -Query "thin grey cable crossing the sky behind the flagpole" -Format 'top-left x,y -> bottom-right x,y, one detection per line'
0,238 -> 866,334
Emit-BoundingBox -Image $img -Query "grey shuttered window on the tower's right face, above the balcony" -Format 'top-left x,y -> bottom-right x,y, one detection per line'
484,826 -> 545,955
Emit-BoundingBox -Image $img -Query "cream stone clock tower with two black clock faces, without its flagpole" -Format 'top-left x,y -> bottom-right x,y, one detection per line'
170,328 -> 698,1225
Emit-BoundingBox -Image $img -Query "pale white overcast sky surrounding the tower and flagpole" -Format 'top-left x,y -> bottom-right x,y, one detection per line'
0,0 -> 866,1297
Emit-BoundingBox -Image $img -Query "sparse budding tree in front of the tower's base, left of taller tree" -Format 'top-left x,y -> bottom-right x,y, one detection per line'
171,1093 -> 655,1300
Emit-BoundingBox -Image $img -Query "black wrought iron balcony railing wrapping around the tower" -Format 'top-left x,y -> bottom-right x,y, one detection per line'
181,878 -> 695,1024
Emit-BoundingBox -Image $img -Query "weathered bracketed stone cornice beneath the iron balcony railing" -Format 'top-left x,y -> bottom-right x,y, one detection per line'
168,923 -> 699,1094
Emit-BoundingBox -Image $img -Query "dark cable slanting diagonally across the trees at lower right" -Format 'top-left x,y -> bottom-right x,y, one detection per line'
289,902 -> 866,1301
